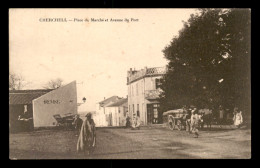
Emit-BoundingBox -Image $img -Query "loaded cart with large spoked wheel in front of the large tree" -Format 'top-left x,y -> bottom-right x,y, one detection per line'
163,109 -> 186,130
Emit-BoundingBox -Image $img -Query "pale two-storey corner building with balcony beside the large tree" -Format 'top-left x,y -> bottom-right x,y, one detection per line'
127,67 -> 166,125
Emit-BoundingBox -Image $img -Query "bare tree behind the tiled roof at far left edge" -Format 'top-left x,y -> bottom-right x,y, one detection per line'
9,72 -> 27,90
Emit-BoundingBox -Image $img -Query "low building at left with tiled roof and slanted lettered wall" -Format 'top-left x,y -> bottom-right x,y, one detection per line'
9,81 -> 77,131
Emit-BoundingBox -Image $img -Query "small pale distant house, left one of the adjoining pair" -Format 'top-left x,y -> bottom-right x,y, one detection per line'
93,96 -> 126,127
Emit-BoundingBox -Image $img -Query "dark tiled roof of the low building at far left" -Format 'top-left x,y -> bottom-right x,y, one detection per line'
9,89 -> 53,104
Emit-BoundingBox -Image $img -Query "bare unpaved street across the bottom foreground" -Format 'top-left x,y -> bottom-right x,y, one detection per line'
10,126 -> 251,159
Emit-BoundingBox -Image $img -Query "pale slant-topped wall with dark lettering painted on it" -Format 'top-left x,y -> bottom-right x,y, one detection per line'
33,81 -> 77,127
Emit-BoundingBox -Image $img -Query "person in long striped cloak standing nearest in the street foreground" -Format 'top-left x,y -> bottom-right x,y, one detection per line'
77,113 -> 96,155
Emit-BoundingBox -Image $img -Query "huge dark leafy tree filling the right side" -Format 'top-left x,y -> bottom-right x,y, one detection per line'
160,9 -> 251,117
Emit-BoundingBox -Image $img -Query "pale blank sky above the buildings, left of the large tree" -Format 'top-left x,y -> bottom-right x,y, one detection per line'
9,9 -> 196,112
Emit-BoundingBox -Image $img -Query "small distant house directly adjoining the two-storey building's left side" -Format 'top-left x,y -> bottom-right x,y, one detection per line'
105,98 -> 128,126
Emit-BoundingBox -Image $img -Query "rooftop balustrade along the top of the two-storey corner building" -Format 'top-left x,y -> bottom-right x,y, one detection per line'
128,67 -> 166,82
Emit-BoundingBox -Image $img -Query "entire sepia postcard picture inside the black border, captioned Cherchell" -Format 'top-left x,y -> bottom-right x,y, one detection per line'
8,8 -> 251,160
